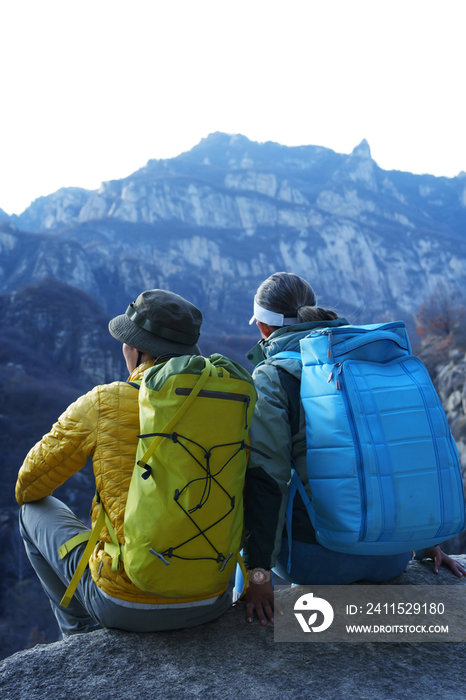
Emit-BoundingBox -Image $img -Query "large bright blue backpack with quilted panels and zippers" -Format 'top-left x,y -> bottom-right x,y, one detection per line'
271,321 -> 466,554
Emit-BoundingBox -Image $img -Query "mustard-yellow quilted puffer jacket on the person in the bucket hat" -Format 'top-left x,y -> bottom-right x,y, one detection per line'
16,361 -> 209,603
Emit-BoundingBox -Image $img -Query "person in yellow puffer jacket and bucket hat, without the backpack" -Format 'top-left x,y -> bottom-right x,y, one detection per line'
16,289 -> 230,636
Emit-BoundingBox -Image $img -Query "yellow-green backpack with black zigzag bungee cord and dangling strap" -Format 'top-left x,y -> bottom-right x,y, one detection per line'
58,354 -> 256,607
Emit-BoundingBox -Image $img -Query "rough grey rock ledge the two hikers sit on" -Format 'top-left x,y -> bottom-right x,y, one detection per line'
0,556 -> 466,700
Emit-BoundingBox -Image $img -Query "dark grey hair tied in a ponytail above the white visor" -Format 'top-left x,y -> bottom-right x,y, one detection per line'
256,272 -> 338,327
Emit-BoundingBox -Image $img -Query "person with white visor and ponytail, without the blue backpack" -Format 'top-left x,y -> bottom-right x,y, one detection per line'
240,272 -> 466,625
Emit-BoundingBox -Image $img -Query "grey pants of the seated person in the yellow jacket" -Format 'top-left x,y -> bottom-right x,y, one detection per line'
19,496 -> 231,637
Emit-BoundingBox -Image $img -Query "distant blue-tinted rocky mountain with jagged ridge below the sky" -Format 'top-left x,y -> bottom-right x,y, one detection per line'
0,134 -> 466,332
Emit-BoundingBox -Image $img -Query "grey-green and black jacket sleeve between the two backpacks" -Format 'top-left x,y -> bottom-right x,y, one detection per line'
243,364 -> 292,568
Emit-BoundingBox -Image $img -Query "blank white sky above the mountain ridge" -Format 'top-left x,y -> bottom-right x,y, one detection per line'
0,0 -> 466,214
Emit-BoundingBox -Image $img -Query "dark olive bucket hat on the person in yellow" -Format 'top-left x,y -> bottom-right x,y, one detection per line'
108,289 -> 202,358
